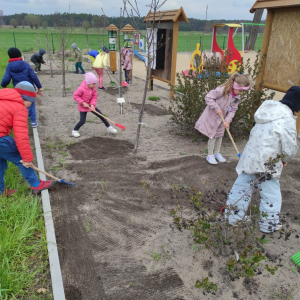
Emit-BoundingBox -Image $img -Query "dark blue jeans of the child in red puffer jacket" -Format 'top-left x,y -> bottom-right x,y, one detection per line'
0,135 -> 40,195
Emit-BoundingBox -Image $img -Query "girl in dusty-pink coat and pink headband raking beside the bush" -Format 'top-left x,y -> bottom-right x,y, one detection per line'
195,72 -> 250,165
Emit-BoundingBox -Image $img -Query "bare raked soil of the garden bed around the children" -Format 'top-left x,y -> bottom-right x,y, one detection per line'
28,54 -> 300,300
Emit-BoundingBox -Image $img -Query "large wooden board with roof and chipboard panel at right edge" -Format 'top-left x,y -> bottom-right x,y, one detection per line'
250,0 -> 300,134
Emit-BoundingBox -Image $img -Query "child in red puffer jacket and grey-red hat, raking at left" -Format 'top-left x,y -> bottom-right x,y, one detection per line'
0,81 -> 54,196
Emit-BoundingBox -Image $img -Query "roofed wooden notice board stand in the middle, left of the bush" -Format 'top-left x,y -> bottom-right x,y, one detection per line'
143,7 -> 189,98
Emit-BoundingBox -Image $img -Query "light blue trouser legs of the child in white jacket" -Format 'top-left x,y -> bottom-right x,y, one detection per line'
225,172 -> 282,233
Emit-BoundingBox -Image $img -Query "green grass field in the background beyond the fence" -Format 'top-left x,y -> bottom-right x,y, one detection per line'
0,27 -> 262,52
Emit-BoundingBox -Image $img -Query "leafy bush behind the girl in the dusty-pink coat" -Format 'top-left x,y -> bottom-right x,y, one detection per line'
169,53 -> 274,136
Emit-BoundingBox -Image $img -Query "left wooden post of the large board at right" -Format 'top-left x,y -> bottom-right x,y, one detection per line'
256,9 -> 274,90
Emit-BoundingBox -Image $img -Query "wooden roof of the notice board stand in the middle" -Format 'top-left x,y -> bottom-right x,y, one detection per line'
143,6 -> 189,23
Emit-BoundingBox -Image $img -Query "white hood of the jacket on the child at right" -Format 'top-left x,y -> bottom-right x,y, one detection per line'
254,100 -> 293,124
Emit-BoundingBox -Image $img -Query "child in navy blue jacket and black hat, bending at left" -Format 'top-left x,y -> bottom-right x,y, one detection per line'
1,48 -> 43,127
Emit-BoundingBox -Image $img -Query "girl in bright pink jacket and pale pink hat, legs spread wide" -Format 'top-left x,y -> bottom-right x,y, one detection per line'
72,72 -> 117,137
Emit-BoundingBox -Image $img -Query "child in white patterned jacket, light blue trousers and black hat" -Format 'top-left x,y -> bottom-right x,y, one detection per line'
225,86 -> 300,233
